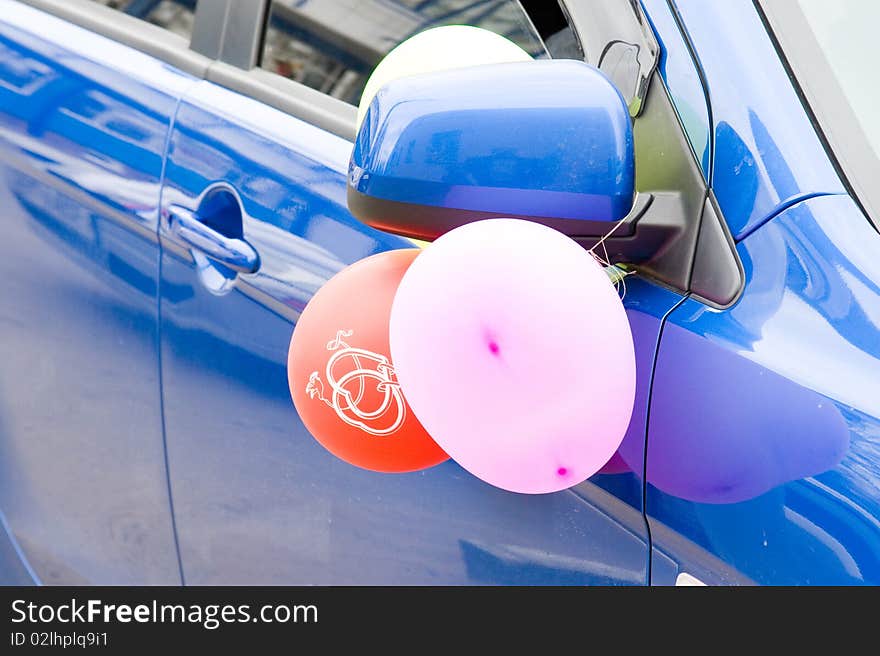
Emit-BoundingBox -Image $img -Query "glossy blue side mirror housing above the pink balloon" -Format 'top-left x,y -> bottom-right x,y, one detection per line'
348,60 -> 635,239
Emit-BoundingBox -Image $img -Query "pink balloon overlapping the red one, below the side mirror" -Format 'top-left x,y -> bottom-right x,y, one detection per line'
390,219 -> 635,494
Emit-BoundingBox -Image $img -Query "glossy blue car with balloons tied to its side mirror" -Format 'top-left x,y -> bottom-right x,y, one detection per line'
0,0 -> 880,585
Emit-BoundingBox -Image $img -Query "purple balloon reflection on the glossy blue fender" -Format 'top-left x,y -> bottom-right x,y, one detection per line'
620,322 -> 849,504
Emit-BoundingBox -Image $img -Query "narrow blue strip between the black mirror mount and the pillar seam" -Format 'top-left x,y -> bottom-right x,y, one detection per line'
641,0 -> 712,180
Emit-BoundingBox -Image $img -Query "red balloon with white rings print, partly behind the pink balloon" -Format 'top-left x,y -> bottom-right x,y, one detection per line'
287,248 -> 449,473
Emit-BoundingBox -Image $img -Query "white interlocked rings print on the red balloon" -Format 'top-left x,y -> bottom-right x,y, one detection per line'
306,330 -> 406,436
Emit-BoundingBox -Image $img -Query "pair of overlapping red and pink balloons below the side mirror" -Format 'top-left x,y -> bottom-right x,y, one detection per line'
288,219 -> 635,493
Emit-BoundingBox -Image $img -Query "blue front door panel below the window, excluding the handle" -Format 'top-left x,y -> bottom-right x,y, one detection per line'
161,82 -> 659,584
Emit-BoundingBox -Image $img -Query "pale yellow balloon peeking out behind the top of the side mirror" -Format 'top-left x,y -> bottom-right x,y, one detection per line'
357,25 -> 532,129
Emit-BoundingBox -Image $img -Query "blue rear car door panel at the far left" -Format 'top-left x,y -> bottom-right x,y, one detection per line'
0,0 -> 203,585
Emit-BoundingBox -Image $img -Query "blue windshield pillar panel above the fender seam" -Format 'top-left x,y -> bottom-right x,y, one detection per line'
674,0 -> 846,239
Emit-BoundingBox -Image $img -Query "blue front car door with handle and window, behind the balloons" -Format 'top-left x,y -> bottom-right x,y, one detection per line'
160,0 -> 682,584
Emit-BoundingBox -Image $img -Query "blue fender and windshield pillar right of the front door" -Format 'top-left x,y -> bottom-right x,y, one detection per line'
646,0 -> 880,585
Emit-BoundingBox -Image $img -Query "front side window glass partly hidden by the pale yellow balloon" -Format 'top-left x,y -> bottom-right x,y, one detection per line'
260,0 -> 547,105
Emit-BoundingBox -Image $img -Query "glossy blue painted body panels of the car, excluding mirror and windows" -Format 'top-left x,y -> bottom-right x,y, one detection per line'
0,0 -> 880,584
